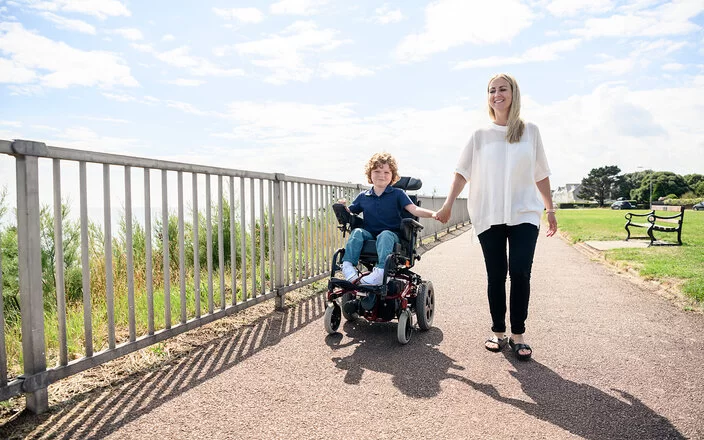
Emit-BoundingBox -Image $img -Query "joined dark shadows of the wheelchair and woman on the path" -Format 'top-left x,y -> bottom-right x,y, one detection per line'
326,320 -> 685,440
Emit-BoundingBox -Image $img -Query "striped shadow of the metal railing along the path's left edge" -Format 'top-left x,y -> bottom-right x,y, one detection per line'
0,294 -> 325,439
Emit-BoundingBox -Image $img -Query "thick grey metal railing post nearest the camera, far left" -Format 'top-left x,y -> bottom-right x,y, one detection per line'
12,140 -> 49,414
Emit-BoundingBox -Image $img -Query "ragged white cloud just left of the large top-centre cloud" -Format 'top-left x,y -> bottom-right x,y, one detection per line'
232,21 -> 349,84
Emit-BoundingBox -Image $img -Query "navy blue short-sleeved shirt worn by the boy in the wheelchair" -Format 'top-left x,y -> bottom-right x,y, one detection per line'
350,185 -> 413,237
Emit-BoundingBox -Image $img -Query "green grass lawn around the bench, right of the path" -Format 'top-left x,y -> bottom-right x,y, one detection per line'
557,208 -> 704,303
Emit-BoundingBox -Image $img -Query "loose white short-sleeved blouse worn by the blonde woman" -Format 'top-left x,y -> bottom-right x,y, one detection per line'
455,123 -> 550,241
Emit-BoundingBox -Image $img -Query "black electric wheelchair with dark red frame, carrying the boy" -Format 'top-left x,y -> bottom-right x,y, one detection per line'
324,177 -> 435,344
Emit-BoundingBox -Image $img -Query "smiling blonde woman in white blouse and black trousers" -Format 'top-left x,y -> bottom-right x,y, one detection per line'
435,74 -> 557,360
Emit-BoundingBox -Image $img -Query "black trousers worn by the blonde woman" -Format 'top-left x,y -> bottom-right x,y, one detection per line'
478,223 -> 538,335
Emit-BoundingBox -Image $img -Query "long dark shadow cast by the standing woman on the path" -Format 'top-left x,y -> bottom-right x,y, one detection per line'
456,351 -> 685,440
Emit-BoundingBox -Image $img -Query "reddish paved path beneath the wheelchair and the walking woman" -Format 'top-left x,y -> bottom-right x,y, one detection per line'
15,230 -> 704,440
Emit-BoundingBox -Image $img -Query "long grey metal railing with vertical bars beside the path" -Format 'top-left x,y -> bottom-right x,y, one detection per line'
0,140 -> 469,413
